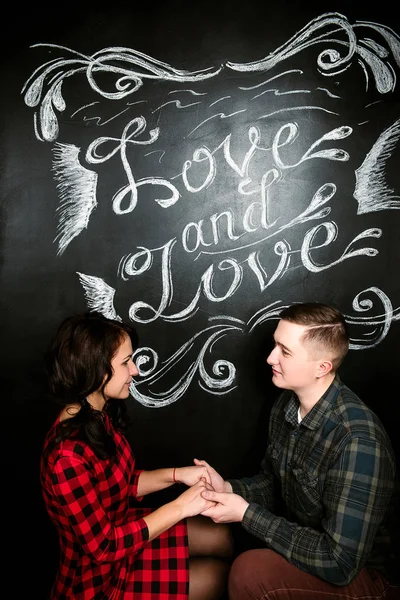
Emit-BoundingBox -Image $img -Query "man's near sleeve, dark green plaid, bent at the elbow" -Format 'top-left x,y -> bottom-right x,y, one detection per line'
243,438 -> 395,586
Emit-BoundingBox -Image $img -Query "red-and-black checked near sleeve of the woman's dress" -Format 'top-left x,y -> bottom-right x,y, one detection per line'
52,456 -> 149,564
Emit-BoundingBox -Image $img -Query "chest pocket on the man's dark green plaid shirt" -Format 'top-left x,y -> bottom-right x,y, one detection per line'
288,468 -> 322,517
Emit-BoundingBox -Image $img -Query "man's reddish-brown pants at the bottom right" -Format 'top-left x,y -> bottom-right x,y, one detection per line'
229,549 -> 400,600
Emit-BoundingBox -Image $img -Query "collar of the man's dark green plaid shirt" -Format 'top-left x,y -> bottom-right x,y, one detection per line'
285,374 -> 342,430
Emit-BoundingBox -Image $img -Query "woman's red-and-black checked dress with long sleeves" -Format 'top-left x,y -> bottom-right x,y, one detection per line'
41,413 -> 189,600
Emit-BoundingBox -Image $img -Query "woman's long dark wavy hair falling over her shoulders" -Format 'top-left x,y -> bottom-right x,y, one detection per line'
45,312 -> 138,459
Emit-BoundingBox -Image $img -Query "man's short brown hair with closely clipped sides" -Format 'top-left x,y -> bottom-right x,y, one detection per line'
280,302 -> 349,371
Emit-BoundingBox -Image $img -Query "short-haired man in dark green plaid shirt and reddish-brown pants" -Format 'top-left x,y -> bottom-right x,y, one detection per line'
195,303 -> 400,600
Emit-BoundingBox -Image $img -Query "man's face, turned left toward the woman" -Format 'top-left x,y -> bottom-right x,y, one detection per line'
267,320 -> 318,393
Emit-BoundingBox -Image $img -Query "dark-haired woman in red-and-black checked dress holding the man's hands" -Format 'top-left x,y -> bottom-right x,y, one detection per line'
41,313 -> 231,600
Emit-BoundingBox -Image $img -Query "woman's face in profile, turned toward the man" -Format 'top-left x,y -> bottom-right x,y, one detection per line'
103,336 -> 139,400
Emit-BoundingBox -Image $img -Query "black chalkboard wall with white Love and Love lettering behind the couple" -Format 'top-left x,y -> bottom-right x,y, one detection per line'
0,0 -> 400,598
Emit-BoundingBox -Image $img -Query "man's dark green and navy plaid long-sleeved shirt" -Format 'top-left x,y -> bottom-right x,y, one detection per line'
229,375 -> 396,586
